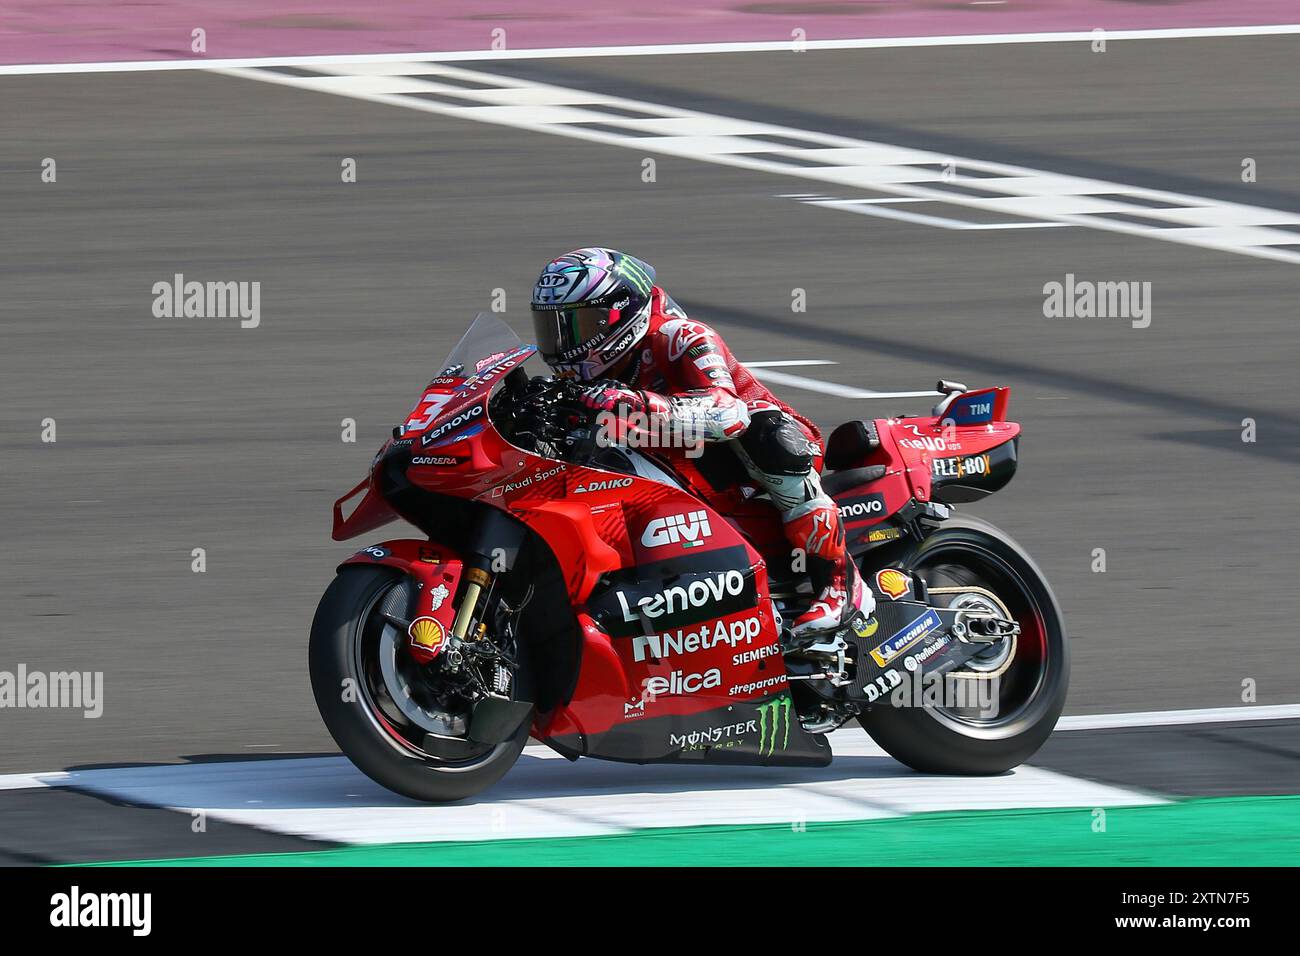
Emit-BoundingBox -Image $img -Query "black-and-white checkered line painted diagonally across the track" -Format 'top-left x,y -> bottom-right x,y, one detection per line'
217,61 -> 1300,263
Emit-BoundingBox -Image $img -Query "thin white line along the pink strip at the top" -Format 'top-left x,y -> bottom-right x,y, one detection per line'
0,23 -> 1300,75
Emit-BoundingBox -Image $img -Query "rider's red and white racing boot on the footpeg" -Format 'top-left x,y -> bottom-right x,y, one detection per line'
784,496 -> 876,643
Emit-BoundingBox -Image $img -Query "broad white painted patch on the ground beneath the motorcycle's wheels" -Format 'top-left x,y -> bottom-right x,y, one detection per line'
32,728 -> 1164,844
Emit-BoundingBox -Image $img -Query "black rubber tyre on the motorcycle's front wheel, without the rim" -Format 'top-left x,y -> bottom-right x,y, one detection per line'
308,566 -> 529,803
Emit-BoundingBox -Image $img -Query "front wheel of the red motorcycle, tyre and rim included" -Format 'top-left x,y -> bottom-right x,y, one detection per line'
308,567 -> 529,803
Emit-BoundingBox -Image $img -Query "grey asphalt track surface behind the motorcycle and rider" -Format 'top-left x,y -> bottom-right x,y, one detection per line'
0,38 -> 1300,785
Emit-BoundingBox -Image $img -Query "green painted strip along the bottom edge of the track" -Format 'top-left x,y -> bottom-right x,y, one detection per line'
78,796 -> 1300,866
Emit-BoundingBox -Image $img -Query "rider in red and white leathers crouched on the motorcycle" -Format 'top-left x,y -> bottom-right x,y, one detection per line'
532,247 -> 875,639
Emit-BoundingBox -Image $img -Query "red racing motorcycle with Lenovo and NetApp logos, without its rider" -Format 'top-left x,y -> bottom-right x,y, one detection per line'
309,313 -> 1070,801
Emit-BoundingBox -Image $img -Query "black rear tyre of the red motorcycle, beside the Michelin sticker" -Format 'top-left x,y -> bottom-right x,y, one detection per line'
858,515 -> 1070,775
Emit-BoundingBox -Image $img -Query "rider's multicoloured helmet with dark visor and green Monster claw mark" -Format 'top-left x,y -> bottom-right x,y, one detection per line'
533,247 -> 654,381
